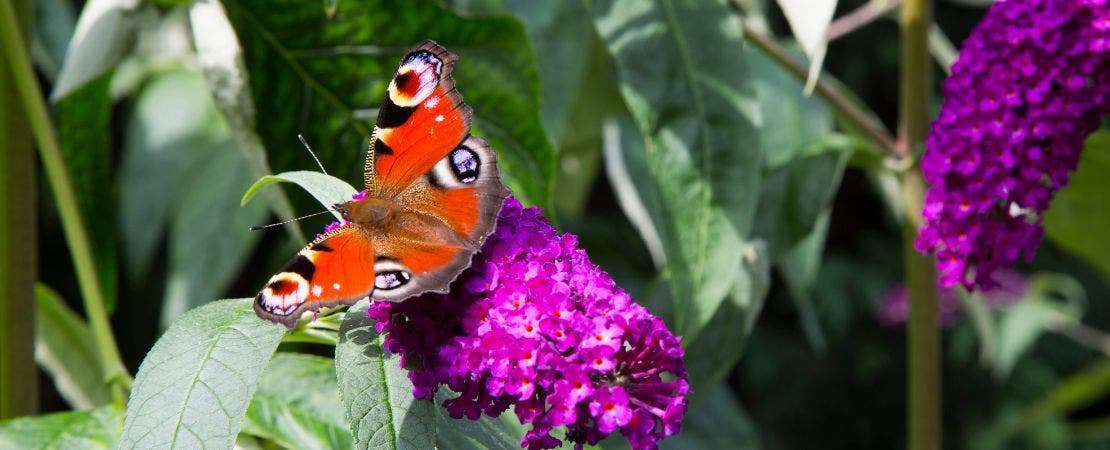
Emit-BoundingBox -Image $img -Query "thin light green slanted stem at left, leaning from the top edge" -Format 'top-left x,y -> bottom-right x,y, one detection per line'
0,0 -> 131,407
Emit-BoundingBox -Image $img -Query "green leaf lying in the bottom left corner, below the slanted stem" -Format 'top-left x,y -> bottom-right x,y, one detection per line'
0,406 -> 123,450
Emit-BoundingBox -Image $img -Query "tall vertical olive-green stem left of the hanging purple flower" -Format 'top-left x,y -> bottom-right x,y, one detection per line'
898,0 -> 941,450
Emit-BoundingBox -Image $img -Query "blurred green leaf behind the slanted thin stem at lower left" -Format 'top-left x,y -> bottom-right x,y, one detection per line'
34,284 -> 111,410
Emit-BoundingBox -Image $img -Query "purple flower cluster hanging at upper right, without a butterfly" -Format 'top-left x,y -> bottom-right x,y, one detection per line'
916,0 -> 1110,289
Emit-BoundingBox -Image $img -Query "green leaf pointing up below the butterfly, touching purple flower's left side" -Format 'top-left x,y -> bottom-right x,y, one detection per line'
335,300 -> 435,449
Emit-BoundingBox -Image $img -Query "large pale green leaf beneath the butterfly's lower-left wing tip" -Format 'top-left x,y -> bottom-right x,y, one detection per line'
120,299 -> 285,449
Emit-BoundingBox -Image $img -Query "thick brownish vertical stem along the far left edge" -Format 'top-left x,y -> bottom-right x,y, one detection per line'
0,1 -> 39,419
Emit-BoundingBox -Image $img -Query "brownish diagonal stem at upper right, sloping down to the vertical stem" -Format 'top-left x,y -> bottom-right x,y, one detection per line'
740,19 -> 906,157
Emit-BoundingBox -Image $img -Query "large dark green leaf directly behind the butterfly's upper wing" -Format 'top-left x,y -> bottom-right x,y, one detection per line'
226,0 -> 554,204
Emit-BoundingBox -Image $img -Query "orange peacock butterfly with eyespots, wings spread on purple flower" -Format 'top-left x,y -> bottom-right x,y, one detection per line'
254,40 -> 508,329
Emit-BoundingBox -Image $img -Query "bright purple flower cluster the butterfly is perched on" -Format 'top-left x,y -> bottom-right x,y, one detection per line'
367,198 -> 689,449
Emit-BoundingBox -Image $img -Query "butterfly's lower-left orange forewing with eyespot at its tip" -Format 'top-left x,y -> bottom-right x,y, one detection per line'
254,223 -> 374,329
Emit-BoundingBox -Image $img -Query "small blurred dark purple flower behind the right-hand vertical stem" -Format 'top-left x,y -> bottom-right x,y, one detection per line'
878,269 -> 1028,328
